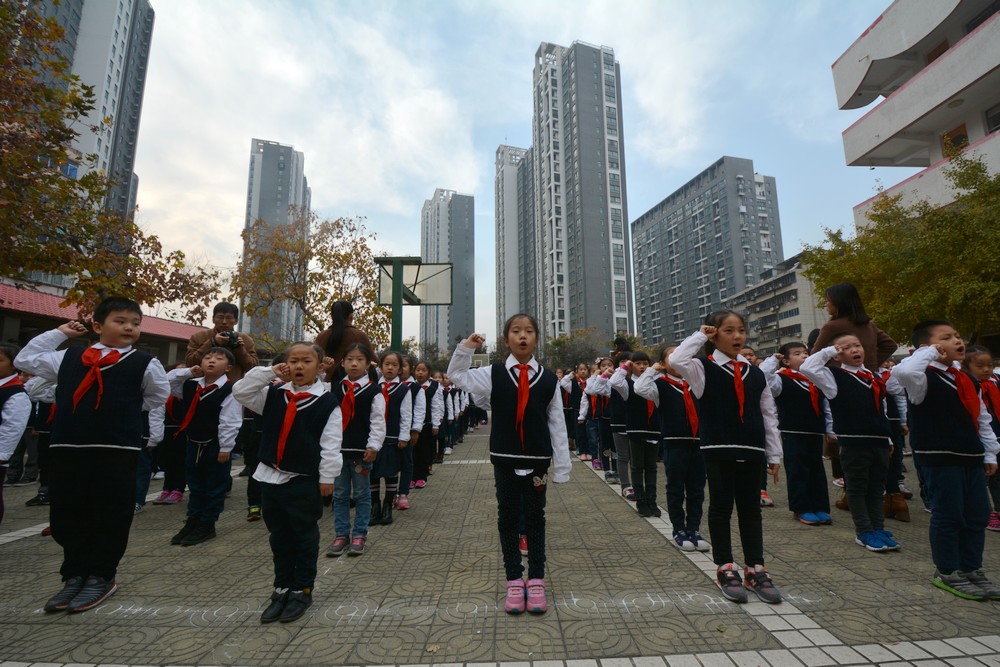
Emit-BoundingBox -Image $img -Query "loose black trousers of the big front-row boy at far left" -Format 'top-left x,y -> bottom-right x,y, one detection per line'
49,447 -> 138,581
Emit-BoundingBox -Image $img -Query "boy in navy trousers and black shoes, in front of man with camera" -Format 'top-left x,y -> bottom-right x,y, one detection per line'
167,347 -> 243,547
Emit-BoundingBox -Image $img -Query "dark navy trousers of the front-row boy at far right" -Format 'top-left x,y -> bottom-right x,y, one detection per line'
921,465 -> 990,574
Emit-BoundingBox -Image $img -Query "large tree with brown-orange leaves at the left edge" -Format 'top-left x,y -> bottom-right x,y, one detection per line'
0,1 -> 219,322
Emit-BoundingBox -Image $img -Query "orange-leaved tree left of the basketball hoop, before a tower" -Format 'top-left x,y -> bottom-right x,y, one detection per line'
230,207 -> 392,349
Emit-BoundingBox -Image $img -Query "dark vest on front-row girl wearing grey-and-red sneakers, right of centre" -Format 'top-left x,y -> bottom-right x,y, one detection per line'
698,357 -> 767,464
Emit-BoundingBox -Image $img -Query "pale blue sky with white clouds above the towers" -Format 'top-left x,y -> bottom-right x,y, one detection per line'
135,0 -> 913,341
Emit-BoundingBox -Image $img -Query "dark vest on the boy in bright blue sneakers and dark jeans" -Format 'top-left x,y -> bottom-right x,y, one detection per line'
830,368 -> 891,447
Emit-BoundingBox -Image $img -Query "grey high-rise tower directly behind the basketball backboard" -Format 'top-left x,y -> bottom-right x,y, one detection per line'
420,188 -> 476,351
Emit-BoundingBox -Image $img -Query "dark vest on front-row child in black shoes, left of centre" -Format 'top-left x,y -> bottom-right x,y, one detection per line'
260,386 -> 339,477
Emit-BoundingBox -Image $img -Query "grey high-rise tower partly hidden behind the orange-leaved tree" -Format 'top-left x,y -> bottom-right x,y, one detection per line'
240,139 -> 312,342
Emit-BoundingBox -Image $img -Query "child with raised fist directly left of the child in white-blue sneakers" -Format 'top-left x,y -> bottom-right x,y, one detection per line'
609,350 -> 661,517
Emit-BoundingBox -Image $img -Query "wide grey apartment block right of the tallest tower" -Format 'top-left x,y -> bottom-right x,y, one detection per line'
632,156 -> 783,344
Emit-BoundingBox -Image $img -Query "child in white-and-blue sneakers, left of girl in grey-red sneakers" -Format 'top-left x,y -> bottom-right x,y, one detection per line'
634,345 -> 711,551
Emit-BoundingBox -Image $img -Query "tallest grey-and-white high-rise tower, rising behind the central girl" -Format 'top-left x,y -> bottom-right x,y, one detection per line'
525,42 -> 633,340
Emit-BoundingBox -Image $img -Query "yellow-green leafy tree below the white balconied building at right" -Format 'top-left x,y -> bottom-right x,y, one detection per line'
803,153 -> 1000,341
